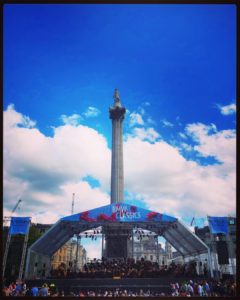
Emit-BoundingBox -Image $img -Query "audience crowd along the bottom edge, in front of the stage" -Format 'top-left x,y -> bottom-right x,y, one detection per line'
3,279 -> 236,297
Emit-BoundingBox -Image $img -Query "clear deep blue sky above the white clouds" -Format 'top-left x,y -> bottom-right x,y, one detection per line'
4,4 -> 236,134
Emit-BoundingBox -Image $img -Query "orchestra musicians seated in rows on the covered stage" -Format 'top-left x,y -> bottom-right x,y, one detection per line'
50,258 -> 201,278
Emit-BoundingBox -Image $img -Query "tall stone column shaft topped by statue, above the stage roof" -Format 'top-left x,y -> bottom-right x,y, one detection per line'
109,89 -> 126,204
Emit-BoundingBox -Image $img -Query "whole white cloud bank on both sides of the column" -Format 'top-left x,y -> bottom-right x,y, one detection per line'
4,106 -> 236,223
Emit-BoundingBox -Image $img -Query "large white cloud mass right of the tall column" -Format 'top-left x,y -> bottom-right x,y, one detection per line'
124,120 -> 236,216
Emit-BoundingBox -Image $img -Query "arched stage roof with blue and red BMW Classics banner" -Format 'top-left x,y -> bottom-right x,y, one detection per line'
27,203 -> 208,256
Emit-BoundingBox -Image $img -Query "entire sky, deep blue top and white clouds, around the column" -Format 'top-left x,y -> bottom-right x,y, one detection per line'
3,4 -> 236,258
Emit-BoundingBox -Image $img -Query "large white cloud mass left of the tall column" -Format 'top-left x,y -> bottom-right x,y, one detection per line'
4,107 -> 111,223
